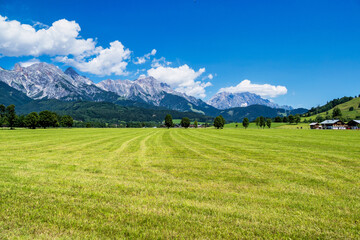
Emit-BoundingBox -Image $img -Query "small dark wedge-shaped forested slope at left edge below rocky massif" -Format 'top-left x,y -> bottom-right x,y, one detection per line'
0,82 -> 31,106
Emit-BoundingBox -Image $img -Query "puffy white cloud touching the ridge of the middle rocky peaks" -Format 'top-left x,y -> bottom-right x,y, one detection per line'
147,64 -> 211,98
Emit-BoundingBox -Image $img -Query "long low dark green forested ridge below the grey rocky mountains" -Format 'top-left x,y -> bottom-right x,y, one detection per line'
16,99 -> 213,123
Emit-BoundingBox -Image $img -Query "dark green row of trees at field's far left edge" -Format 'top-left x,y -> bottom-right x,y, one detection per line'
0,104 -> 74,129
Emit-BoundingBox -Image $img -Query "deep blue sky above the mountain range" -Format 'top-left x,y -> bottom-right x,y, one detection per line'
0,0 -> 360,107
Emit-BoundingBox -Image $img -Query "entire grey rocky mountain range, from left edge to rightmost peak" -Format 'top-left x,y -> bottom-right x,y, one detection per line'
0,63 -> 304,116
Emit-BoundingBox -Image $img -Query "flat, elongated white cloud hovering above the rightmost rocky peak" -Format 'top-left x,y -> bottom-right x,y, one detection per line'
219,79 -> 287,98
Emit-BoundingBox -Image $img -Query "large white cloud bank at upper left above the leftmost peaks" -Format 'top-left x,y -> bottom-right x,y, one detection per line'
0,15 -> 132,76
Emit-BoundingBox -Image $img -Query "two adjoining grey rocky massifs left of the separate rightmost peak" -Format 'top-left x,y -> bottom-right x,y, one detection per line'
0,63 -> 219,115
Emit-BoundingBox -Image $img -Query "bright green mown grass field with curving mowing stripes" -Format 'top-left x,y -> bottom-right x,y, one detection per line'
0,128 -> 360,239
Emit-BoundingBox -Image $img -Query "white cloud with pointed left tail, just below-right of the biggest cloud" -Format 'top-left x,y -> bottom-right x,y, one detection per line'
55,41 -> 131,76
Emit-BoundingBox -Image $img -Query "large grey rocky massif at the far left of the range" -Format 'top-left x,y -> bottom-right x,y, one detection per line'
0,63 -> 118,101
